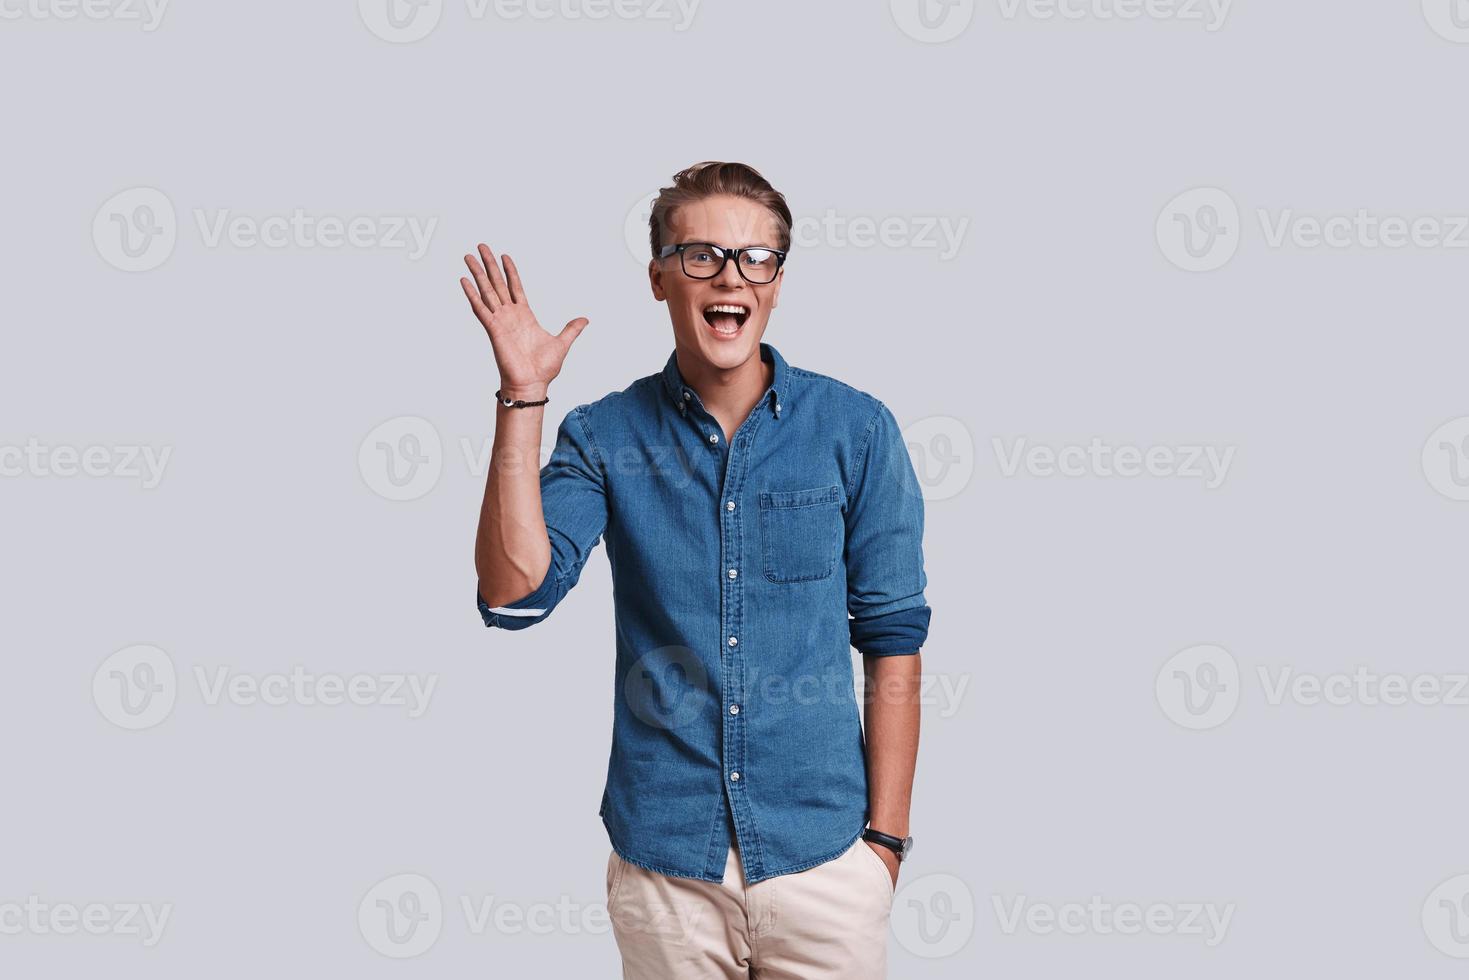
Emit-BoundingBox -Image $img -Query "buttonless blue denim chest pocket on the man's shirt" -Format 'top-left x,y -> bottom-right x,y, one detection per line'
759,483 -> 846,582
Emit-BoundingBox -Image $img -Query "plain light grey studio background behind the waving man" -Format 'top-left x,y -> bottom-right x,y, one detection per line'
0,0 -> 1469,977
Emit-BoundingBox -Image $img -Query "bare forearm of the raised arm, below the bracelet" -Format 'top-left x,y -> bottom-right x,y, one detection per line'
474,385 -> 551,605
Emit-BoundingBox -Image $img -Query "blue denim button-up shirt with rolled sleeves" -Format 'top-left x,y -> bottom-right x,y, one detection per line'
474,344 -> 930,883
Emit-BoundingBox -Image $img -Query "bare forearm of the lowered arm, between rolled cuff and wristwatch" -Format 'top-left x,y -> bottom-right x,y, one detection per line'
862,654 -> 923,837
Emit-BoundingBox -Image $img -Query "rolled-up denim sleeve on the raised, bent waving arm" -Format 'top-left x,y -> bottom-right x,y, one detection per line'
474,404 -> 607,629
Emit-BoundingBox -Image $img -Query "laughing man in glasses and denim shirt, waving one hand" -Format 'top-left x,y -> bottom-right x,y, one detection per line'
460,163 -> 930,980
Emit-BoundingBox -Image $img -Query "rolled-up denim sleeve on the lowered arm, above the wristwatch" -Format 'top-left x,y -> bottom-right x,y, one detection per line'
845,403 -> 931,657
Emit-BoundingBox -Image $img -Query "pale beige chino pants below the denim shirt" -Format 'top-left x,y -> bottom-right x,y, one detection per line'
607,837 -> 893,980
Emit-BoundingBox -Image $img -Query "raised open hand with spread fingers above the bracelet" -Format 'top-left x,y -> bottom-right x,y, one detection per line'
460,242 -> 591,398
